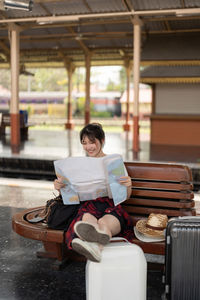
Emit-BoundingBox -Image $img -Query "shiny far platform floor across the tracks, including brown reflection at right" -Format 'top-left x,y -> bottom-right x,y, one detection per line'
0,126 -> 200,167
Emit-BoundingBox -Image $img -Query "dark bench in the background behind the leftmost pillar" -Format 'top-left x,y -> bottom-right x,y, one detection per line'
0,113 -> 29,141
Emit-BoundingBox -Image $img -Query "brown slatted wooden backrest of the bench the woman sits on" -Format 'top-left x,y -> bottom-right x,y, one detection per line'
123,162 -> 196,223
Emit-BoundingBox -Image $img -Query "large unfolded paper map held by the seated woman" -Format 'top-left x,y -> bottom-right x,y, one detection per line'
54,154 -> 127,205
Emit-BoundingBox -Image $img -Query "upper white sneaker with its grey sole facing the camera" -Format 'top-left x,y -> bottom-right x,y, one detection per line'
74,221 -> 110,245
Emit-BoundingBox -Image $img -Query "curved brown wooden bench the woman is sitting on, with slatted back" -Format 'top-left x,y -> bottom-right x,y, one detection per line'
12,162 -> 196,268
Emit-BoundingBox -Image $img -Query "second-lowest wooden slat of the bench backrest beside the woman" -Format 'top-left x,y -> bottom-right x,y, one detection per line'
125,198 -> 195,208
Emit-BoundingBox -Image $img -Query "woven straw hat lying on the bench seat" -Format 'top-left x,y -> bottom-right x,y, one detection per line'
136,213 -> 168,238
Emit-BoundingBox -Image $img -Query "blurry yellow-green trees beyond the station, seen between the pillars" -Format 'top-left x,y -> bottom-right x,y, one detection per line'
0,67 -> 126,92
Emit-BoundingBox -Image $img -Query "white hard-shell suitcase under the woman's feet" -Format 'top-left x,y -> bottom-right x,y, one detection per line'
86,241 -> 147,300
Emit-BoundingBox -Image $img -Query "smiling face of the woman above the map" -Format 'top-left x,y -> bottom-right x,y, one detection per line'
82,136 -> 104,157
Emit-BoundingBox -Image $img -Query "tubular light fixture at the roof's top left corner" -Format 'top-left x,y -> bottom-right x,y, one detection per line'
0,0 -> 33,11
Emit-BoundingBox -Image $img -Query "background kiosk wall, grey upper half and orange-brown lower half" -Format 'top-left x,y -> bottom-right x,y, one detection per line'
150,83 -> 200,147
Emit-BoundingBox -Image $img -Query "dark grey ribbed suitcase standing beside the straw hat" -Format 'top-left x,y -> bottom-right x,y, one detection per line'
165,217 -> 200,300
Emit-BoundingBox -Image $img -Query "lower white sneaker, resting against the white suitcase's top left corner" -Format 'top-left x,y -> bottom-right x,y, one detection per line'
72,238 -> 101,262
